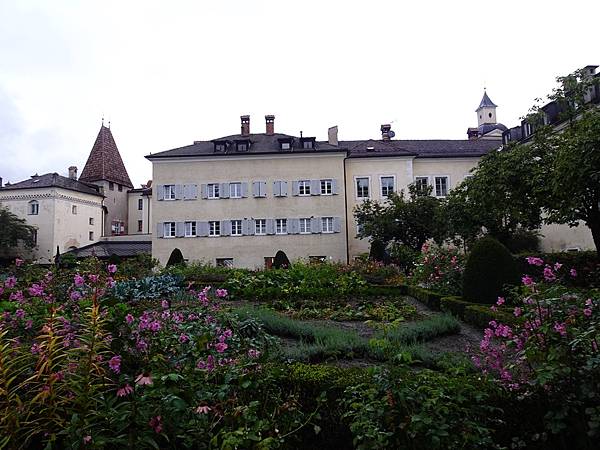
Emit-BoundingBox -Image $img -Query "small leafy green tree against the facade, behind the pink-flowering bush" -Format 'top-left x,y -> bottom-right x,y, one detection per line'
354,184 -> 440,251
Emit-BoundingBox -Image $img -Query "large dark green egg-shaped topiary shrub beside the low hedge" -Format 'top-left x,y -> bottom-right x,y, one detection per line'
463,237 -> 519,304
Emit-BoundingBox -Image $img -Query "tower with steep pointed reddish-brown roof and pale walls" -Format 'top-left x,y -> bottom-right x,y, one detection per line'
79,120 -> 133,236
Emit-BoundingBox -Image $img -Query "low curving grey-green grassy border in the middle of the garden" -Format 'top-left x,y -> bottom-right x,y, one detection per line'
234,307 -> 460,365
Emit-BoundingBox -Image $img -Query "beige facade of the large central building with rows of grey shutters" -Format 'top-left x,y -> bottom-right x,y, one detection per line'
152,153 -> 347,268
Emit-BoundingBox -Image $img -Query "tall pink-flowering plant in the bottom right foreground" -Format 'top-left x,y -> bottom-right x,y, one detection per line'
473,257 -> 600,442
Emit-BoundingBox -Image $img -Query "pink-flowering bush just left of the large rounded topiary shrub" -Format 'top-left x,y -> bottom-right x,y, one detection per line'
410,243 -> 465,295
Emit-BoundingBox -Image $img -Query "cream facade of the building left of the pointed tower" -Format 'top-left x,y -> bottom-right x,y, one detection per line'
0,187 -> 102,264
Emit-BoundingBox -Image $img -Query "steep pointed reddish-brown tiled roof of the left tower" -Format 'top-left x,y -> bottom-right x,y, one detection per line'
79,124 -> 133,188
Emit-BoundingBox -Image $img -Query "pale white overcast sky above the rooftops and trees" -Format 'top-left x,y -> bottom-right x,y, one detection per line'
0,0 -> 600,186
